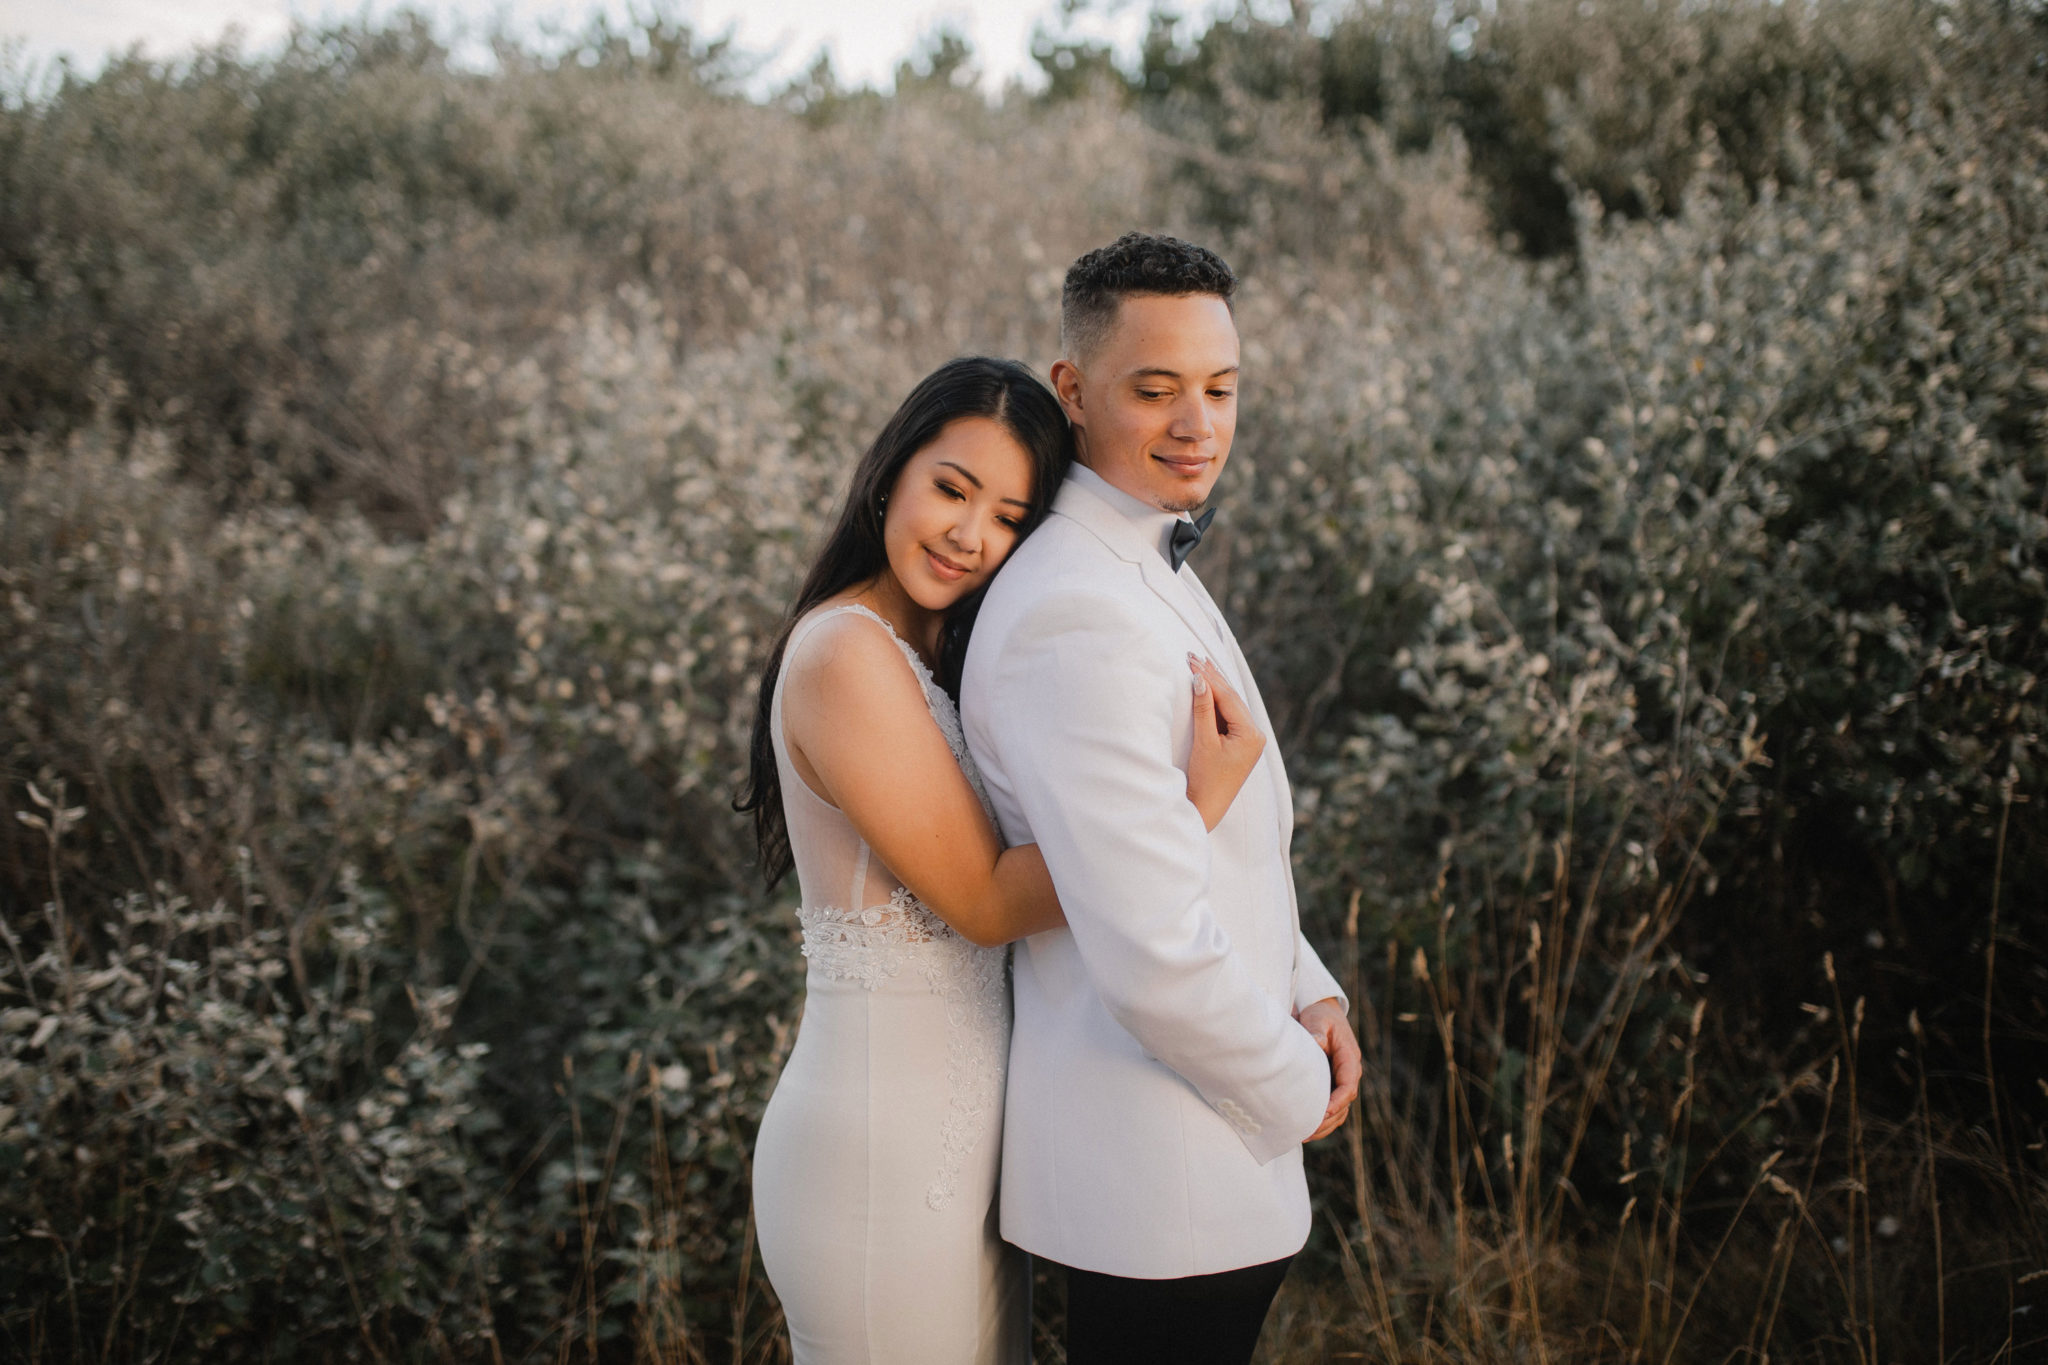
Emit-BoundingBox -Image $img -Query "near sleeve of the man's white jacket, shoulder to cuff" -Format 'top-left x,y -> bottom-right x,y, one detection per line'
989,591 -> 1329,1164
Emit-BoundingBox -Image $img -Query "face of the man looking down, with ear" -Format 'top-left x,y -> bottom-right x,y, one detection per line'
1053,295 -> 1237,512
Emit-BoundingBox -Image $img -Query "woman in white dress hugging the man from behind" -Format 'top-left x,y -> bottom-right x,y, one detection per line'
739,358 -> 1264,1365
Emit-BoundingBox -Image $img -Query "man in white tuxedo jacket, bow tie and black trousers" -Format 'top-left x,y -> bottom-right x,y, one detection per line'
961,233 -> 1360,1365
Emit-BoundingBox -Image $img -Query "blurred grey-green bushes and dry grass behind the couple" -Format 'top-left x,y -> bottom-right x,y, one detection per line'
0,0 -> 2048,1365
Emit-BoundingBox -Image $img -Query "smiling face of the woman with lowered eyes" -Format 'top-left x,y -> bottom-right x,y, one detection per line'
883,417 -> 1032,612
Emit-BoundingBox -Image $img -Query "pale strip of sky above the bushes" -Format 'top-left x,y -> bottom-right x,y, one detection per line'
0,0 -> 1196,92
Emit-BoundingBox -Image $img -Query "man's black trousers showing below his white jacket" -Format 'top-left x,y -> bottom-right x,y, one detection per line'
1067,1257 -> 1294,1365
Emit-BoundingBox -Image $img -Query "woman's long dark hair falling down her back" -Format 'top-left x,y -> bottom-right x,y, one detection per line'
733,356 -> 1073,888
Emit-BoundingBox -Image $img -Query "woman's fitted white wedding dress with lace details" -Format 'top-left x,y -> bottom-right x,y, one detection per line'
754,606 -> 1030,1365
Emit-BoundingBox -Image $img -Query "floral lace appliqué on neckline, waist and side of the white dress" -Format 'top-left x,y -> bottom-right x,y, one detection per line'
797,604 -> 1010,1209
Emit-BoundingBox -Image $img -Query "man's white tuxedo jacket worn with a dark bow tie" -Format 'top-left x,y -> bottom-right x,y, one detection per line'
961,473 -> 1341,1279
